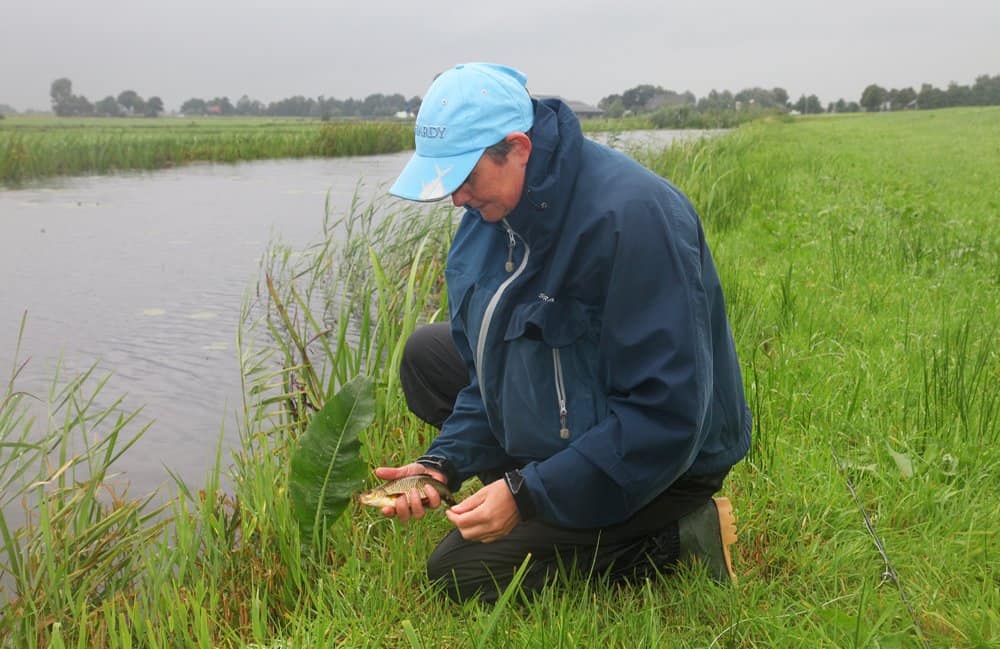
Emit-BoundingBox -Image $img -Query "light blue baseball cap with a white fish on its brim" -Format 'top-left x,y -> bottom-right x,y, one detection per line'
389,63 -> 534,201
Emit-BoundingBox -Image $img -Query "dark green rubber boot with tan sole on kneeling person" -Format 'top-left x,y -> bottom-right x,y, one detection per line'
677,497 -> 736,583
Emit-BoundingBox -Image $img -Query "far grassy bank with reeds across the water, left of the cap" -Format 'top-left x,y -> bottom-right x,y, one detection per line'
0,117 -> 413,185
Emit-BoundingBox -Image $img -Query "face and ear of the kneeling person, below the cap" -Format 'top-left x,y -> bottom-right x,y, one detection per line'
451,136 -> 530,223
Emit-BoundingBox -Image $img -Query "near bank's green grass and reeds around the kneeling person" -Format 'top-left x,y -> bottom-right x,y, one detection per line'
0,109 -> 1000,649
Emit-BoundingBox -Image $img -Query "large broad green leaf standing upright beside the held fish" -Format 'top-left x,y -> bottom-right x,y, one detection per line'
289,376 -> 375,542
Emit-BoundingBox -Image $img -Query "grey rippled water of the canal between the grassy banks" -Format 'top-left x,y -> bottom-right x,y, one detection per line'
0,131 -> 720,495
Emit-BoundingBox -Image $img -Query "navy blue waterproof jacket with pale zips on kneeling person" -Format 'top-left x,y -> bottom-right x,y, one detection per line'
427,100 -> 751,528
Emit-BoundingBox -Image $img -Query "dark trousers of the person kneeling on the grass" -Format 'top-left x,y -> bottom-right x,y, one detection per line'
400,323 -> 726,601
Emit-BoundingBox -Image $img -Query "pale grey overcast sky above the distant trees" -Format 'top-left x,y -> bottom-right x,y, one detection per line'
0,0 -> 1000,110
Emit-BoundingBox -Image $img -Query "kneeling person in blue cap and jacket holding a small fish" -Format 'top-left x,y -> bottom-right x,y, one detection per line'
376,63 -> 750,601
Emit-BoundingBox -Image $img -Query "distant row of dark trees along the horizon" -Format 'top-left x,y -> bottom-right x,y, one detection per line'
39,75 -> 1000,120
